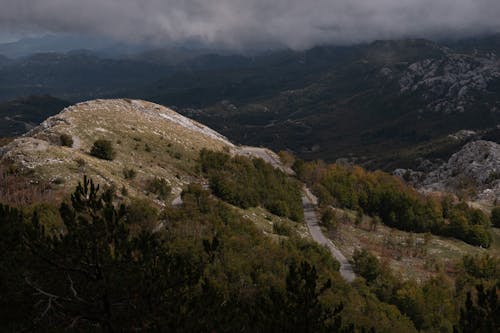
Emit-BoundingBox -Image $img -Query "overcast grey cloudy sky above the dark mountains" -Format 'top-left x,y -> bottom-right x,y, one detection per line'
0,0 -> 500,48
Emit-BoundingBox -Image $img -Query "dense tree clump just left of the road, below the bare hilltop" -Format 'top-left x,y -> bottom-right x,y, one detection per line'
200,150 -> 303,221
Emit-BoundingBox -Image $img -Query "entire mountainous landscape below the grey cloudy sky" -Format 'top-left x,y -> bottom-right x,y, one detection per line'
0,35 -> 500,333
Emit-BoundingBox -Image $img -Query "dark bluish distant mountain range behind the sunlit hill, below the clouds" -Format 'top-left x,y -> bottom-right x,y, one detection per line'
0,35 -> 500,169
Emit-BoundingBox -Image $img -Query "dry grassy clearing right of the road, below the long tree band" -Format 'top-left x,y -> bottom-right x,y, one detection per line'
327,208 -> 494,281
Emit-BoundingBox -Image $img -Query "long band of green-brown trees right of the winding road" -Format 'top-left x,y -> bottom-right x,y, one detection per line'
295,161 -> 491,248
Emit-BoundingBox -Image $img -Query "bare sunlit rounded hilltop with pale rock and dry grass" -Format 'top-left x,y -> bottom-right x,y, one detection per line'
0,99 -> 288,204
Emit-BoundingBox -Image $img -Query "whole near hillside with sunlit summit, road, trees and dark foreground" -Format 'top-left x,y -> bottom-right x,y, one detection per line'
0,99 -> 500,332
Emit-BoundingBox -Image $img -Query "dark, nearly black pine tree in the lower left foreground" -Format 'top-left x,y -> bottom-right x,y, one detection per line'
13,179 -> 201,331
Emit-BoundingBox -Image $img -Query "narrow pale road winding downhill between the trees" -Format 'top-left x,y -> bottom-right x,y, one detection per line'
302,187 -> 356,282
